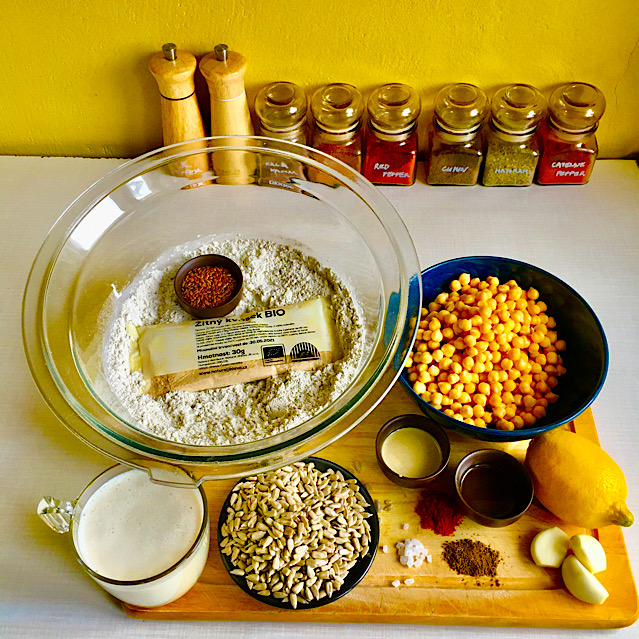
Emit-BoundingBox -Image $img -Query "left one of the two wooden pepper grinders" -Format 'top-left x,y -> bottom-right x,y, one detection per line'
149,43 -> 210,179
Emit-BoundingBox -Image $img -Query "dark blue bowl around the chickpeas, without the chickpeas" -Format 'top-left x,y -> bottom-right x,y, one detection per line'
400,256 -> 608,442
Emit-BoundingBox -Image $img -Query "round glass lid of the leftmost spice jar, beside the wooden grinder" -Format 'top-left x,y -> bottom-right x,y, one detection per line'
255,82 -> 306,131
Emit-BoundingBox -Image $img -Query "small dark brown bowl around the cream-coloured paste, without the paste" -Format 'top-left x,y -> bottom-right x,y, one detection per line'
375,415 -> 450,488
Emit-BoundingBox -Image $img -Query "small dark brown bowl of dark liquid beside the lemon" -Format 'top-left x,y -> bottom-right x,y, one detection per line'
455,449 -> 534,528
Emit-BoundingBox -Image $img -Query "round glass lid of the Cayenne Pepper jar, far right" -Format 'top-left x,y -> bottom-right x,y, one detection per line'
548,82 -> 606,133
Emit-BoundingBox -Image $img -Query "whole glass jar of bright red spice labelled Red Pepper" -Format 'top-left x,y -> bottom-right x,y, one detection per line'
362,84 -> 421,186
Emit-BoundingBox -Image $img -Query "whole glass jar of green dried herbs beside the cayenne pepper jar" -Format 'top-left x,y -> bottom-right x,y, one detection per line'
482,84 -> 546,186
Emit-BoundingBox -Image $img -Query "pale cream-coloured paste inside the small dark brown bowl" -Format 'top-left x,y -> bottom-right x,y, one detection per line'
382,426 -> 442,479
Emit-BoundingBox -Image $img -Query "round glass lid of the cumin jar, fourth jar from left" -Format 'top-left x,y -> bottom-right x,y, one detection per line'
435,82 -> 488,133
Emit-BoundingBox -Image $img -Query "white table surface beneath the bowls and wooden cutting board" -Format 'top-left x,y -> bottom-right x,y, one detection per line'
0,157 -> 639,639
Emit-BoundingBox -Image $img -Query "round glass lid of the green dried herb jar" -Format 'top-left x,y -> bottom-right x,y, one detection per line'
492,84 -> 546,135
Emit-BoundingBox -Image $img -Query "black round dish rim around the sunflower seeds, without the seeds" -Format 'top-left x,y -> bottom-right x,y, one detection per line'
217,457 -> 379,610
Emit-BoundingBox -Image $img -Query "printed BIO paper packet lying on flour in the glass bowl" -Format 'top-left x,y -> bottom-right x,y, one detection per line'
127,297 -> 343,397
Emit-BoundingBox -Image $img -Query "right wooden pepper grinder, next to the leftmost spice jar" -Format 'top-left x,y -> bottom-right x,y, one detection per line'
200,44 -> 256,184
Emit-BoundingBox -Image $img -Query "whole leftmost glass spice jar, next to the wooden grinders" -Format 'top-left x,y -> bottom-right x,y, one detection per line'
255,82 -> 307,191
